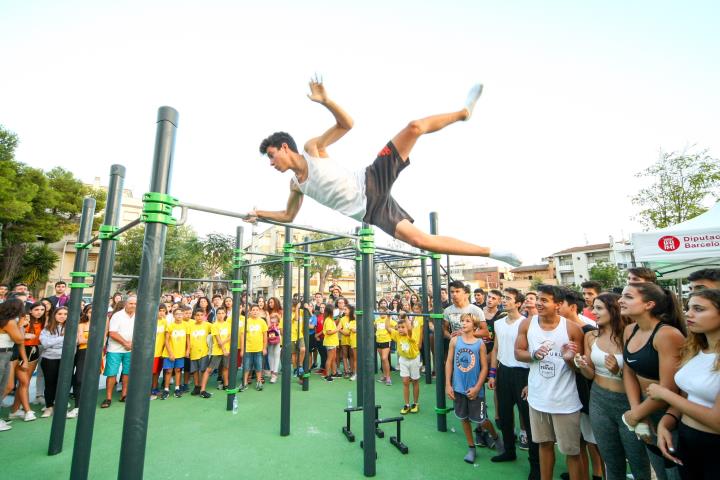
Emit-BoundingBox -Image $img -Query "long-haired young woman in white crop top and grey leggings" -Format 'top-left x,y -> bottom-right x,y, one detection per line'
575,293 -> 650,480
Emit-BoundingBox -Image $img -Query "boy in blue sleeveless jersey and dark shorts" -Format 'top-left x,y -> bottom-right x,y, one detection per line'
445,313 -> 488,463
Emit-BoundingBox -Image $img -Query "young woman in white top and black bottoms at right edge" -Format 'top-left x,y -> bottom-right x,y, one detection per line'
647,289 -> 720,480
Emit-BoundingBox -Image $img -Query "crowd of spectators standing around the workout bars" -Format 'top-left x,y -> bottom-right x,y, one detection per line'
0,268 -> 720,480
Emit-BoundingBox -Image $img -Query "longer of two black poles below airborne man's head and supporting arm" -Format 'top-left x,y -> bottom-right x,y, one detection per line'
280,227 -> 294,437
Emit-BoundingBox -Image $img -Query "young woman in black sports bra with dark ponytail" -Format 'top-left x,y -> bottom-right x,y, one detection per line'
619,282 -> 685,480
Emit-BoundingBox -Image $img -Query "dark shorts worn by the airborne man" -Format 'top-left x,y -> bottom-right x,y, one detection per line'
363,142 -> 415,237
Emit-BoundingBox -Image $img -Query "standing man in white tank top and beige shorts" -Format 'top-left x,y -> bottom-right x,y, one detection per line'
515,285 -> 583,480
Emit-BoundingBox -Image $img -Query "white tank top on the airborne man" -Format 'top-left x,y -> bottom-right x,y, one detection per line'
292,152 -> 367,221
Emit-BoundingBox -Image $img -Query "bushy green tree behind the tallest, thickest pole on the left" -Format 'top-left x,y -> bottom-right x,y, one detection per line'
115,225 -> 204,291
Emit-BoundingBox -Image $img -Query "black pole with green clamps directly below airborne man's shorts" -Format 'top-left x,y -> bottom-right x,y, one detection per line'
360,224 -> 376,477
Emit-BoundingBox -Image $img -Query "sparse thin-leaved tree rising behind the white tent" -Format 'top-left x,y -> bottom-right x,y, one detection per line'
632,150 -> 720,229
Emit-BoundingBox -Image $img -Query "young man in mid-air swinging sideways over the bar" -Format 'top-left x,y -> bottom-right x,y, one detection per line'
246,78 -> 520,266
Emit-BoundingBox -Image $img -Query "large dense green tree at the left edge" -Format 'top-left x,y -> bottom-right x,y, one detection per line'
0,126 -> 105,283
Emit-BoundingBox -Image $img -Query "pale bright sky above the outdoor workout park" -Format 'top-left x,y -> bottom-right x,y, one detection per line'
0,0 -> 720,264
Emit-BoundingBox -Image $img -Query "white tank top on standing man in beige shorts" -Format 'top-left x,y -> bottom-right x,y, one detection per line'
527,315 -> 582,413
